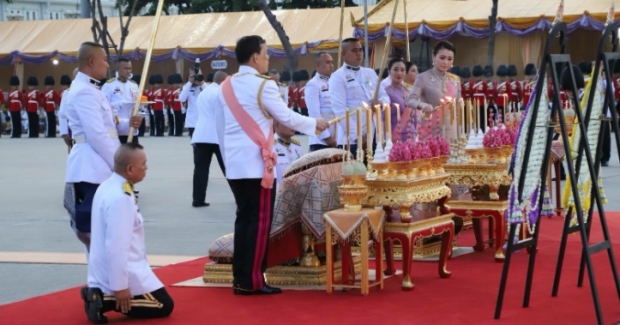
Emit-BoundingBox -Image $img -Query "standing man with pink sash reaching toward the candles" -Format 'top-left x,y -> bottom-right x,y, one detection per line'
215,36 -> 328,295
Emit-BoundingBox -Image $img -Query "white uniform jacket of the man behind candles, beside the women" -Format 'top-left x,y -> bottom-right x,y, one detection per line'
329,63 -> 390,145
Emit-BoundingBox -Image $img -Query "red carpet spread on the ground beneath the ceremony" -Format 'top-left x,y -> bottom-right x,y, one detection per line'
0,213 -> 620,325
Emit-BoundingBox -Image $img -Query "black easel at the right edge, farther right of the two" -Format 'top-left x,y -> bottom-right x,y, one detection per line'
551,23 -> 620,324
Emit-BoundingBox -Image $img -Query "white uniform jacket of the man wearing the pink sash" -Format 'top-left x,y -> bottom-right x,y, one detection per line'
215,65 -> 316,179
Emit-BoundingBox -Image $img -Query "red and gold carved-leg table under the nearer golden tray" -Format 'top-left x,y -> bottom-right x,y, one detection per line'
377,210 -> 454,290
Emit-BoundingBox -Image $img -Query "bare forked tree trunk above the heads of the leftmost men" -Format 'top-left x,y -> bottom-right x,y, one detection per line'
88,0 -> 138,73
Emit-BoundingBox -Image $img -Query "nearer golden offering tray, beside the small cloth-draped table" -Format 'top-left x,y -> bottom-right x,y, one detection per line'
365,173 -> 451,222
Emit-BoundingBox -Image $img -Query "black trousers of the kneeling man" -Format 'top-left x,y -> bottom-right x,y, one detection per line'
101,288 -> 174,318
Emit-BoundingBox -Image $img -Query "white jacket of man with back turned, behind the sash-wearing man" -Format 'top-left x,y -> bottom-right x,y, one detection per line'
191,82 -> 220,144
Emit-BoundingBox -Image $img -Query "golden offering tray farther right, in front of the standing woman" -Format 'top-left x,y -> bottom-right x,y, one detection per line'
443,162 -> 512,201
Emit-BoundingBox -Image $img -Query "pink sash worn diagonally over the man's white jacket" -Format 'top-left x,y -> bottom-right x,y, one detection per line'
222,77 -> 277,189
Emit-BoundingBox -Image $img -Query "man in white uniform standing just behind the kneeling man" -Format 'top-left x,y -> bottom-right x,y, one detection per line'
64,42 -> 142,250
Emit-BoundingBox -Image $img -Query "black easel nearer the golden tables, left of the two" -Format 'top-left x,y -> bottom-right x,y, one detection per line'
495,22 -> 619,324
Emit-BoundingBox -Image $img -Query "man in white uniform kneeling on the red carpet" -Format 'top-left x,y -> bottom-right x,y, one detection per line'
81,143 -> 174,324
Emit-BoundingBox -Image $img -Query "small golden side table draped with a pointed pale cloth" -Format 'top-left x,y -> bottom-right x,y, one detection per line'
323,209 -> 385,295
